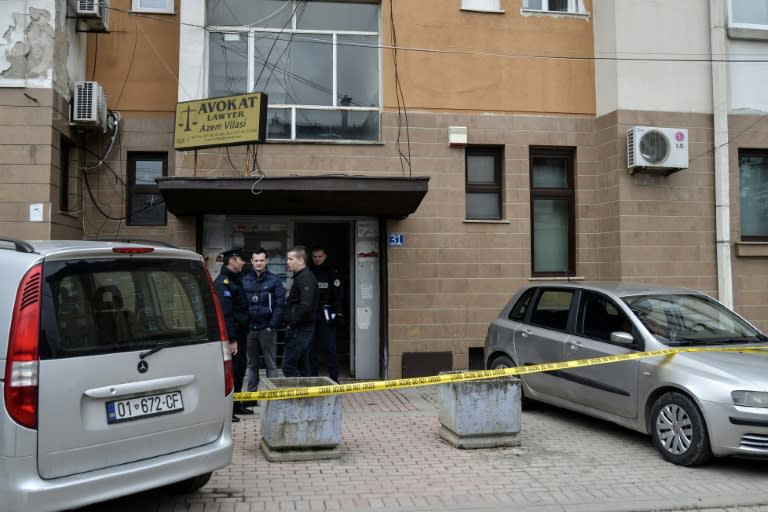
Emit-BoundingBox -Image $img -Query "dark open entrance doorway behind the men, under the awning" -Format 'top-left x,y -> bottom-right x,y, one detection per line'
293,221 -> 354,378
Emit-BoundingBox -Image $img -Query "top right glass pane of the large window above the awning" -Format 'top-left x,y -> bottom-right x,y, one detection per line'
296,2 -> 379,32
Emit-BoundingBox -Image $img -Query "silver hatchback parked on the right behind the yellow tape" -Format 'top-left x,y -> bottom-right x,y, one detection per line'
485,282 -> 768,466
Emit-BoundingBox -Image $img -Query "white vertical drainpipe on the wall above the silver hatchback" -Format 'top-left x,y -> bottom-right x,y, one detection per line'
709,0 -> 733,308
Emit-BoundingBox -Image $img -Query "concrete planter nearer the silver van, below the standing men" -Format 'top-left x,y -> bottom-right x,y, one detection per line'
259,377 -> 341,462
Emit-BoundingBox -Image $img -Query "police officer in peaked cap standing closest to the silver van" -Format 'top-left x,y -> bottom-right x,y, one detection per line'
214,249 -> 253,422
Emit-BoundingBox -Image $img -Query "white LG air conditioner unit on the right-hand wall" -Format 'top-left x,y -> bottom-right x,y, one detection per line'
627,126 -> 688,175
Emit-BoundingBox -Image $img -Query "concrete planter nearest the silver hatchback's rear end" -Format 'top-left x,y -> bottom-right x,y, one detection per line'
438,372 -> 522,449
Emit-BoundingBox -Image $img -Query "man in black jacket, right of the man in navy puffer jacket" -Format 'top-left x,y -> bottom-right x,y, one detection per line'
283,245 -> 318,377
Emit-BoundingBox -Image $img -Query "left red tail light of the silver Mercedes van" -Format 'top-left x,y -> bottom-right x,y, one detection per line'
4,265 -> 43,429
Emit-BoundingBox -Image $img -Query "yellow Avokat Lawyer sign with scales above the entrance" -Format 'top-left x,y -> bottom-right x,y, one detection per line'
173,92 -> 267,151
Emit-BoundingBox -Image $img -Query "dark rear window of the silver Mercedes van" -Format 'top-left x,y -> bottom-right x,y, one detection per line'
40,258 -> 220,359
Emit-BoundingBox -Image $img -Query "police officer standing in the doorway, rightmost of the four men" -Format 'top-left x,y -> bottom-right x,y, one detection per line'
310,246 -> 344,382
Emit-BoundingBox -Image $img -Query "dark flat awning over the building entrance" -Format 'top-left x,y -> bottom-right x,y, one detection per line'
157,176 -> 429,218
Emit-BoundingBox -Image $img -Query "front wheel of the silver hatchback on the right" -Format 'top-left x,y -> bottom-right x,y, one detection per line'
651,392 -> 712,466
